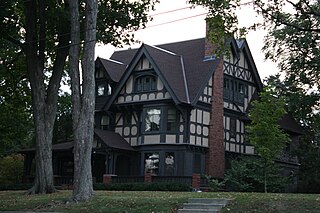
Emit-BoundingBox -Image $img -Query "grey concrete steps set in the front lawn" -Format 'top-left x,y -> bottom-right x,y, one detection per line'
178,198 -> 228,213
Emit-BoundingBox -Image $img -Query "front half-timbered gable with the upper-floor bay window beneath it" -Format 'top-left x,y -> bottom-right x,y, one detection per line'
96,45 -> 191,149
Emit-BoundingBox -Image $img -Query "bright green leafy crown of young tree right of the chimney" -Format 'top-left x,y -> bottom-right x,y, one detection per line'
247,88 -> 290,163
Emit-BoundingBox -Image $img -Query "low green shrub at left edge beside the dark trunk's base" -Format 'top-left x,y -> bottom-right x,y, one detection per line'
0,155 -> 24,184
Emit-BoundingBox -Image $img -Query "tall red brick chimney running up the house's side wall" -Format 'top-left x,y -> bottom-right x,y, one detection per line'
205,17 -> 225,178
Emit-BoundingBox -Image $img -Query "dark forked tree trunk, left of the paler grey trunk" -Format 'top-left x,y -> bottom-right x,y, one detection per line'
23,0 -> 68,194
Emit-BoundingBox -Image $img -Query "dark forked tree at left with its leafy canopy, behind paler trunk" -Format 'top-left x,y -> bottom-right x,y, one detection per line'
0,0 -> 155,194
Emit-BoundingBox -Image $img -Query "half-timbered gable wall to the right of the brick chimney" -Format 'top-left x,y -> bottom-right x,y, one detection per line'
223,40 -> 262,154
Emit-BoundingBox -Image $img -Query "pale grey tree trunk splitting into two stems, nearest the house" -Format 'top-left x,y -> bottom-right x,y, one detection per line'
69,0 -> 97,202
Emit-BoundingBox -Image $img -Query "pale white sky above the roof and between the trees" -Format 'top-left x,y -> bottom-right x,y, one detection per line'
96,0 -> 278,80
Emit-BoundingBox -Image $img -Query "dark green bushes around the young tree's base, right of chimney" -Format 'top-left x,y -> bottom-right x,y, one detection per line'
225,156 -> 288,192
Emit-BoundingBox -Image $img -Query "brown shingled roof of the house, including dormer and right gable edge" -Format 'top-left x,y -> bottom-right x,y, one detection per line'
99,38 -> 262,105
